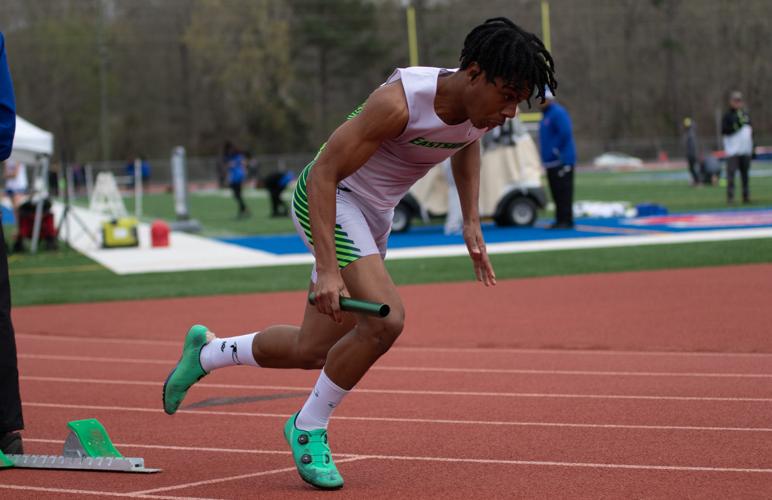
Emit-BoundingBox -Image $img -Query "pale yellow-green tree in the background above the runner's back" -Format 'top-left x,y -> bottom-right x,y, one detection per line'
184,0 -> 303,153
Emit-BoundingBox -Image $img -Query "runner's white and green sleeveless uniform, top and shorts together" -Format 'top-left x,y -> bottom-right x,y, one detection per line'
292,67 -> 486,272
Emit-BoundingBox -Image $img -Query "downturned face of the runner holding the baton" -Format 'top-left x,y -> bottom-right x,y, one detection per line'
465,65 -> 530,129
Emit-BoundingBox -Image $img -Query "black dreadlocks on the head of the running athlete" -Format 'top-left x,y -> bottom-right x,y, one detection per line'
459,17 -> 558,107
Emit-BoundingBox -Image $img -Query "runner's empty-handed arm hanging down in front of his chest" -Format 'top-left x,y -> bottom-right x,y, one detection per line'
451,140 -> 496,286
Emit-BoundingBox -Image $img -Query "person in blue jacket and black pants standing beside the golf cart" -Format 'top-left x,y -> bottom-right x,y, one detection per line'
539,87 -> 576,229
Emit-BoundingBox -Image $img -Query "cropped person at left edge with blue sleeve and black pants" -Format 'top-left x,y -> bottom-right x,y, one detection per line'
0,33 -> 24,454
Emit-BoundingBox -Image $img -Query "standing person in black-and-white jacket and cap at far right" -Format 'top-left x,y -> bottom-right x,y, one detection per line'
721,90 -> 753,204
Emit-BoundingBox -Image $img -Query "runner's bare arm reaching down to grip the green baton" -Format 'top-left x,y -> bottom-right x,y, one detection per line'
308,83 -> 408,323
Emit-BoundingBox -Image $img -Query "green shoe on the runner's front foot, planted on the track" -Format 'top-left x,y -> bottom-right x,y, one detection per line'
284,413 -> 343,490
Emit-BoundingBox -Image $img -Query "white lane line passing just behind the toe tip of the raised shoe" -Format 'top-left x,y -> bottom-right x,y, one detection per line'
23,402 -> 772,432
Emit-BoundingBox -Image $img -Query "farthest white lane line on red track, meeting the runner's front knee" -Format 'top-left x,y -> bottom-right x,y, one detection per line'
16,332 -> 772,358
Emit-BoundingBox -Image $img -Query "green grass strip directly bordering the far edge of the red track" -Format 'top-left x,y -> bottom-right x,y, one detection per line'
9,238 -> 772,306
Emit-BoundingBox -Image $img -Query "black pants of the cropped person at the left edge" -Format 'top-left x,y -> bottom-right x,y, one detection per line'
0,223 -> 24,435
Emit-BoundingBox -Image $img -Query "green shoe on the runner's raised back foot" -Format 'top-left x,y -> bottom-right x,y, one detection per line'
163,325 -> 214,415
